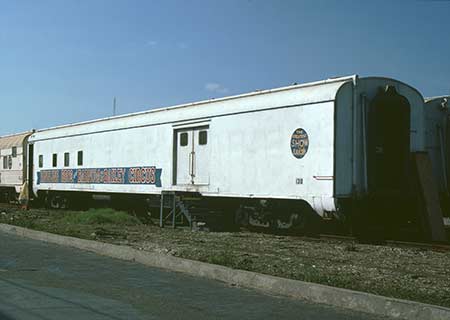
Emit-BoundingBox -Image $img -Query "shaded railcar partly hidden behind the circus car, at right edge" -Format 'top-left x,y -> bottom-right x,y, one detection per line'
425,96 -> 450,216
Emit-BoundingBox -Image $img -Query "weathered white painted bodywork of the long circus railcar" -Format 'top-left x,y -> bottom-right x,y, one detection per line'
30,76 -> 424,214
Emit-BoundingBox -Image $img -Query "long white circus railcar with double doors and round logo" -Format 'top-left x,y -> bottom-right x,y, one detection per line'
29,76 -> 425,231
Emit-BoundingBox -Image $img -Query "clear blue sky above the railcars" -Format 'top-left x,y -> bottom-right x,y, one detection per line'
0,0 -> 450,134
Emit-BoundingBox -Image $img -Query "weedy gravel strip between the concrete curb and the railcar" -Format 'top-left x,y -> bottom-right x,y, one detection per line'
0,206 -> 450,307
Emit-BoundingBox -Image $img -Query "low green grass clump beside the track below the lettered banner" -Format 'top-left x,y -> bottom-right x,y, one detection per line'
63,208 -> 141,226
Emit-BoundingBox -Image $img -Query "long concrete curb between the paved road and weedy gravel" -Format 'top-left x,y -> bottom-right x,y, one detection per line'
0,224 -> 450,320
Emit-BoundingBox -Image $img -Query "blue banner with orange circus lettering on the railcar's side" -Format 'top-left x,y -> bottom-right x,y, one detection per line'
37,167 -> 162,187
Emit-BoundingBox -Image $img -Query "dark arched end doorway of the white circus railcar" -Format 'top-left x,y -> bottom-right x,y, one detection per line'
358,86 -> 420,239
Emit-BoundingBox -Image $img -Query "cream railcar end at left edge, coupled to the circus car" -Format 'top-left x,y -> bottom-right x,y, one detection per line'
0,132 -> 32,201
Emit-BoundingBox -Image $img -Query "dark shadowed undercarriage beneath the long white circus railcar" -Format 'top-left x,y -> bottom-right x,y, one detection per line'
23,191 -> 446,241
